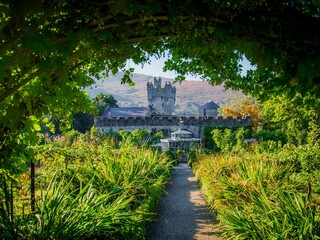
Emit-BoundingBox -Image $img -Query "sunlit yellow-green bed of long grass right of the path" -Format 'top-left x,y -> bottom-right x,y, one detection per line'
194,146 -> 320,239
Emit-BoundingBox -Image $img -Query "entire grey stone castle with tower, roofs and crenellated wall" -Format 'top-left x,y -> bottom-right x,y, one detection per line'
95,78 -> 251,139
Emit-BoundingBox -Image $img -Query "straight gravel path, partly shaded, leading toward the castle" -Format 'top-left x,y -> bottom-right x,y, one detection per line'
147,163 -> 221,240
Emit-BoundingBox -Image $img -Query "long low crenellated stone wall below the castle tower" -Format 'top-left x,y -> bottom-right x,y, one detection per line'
95,116 -> 251,138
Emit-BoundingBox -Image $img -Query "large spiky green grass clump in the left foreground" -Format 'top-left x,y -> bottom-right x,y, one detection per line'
28,177 -> 143,239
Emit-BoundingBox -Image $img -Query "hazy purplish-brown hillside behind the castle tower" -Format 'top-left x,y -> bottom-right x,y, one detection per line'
86,73 -> 243,114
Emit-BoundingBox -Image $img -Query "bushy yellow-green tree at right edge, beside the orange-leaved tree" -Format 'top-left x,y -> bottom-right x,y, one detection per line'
262,93 -> 320,145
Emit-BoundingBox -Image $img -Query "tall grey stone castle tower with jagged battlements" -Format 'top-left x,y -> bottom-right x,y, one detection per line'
147,78 -> 176,115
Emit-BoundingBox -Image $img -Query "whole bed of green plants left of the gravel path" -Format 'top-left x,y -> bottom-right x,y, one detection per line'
0,131 -> 172,239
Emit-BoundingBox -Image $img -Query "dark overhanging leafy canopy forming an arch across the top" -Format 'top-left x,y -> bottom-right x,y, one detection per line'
0,0 -> 320,176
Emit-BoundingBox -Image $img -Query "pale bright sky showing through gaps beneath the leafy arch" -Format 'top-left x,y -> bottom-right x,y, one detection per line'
127,57 -> 253,81
